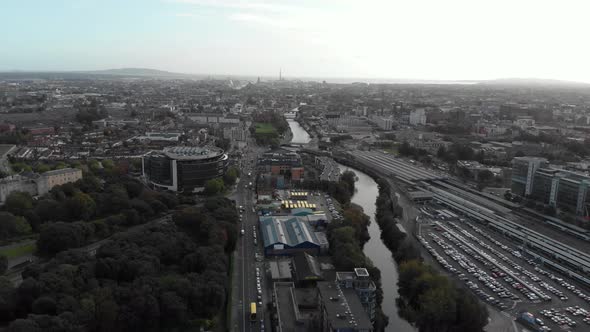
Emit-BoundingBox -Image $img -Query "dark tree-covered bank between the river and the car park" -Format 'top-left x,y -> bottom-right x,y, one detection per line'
339,158 -> 488,331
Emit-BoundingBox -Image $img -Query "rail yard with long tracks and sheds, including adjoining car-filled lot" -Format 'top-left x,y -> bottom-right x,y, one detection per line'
353,151 -> 590,331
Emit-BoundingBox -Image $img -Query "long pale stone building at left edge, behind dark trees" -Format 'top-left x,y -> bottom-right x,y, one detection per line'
0,168 -> 82,204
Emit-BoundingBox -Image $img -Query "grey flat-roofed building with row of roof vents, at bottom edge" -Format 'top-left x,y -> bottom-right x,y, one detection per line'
317,281 -> 373,332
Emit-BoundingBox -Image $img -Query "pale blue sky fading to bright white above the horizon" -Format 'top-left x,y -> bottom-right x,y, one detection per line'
0,0 -> 590,83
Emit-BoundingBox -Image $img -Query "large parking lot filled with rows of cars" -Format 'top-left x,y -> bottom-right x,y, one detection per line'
418,209 -> 590,331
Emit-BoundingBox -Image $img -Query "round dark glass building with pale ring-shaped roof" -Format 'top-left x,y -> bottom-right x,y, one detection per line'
142,147 -> 228,192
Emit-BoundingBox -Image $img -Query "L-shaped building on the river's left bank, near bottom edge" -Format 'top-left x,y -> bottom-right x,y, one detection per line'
336,268 -> 377,322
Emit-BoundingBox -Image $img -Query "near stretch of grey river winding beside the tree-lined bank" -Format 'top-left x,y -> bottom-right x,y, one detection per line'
338,164 -> 416,332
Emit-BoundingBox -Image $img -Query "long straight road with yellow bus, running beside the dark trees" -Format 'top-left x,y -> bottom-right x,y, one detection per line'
231,142 -> 272,331
